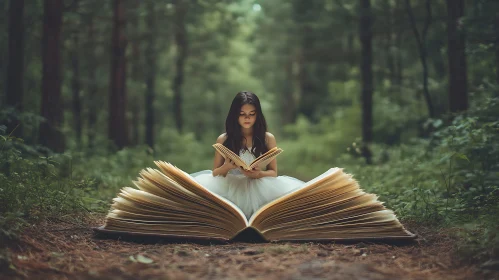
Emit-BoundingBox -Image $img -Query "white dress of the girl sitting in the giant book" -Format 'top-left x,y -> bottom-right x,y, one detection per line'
191,150 -> 305,219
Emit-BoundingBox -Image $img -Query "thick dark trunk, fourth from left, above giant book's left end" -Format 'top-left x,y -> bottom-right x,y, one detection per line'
108,0 -> 128,149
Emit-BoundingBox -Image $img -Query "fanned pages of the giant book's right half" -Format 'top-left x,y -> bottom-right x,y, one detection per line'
249,168 -> 415,241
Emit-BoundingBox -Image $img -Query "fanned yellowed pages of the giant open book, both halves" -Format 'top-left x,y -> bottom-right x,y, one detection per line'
94,161 -> 415,241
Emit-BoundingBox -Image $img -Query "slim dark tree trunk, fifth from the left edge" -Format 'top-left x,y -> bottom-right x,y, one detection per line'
145,2 -> 157,148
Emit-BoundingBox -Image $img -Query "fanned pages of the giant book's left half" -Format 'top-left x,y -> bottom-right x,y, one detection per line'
99,162 -> 248,240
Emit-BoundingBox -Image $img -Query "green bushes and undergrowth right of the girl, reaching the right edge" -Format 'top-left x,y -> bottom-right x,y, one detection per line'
278,94 -> 499,261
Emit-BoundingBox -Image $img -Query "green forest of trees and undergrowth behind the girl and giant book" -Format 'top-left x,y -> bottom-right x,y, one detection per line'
0,0 -> 499,272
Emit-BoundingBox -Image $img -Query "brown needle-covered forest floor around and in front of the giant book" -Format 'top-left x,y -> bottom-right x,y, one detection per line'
0,214 -> 499,280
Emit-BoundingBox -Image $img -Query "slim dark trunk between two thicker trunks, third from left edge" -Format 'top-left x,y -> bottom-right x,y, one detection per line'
71,33 -> 82,146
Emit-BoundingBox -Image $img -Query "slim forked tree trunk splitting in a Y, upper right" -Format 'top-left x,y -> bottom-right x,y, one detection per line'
405,0 -> 435,118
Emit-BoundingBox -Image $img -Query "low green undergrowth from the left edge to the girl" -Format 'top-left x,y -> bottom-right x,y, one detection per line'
0,112 -> 220,244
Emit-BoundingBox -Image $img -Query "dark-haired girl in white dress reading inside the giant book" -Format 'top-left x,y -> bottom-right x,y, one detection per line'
191,91 -> 304,219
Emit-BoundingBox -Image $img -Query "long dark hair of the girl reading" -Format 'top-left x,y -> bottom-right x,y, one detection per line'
224,91 -> 268,157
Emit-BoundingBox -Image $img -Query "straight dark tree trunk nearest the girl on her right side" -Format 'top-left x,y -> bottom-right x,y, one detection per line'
359,0 -> 374,164
